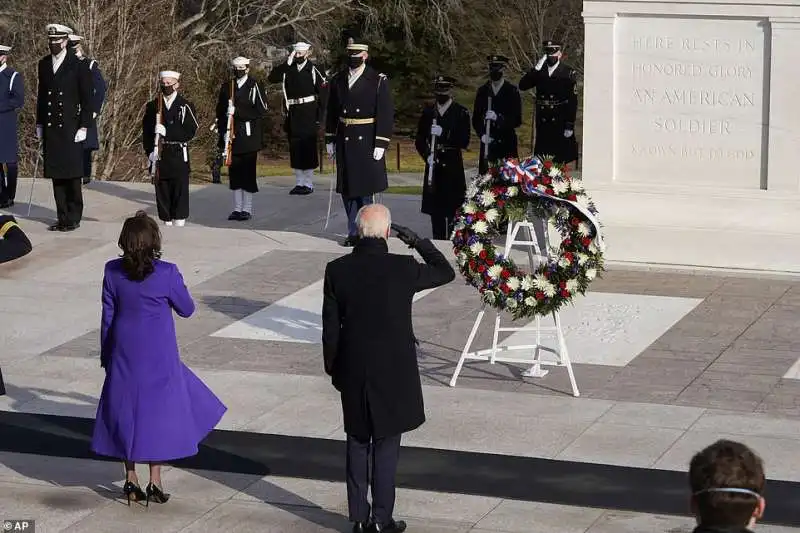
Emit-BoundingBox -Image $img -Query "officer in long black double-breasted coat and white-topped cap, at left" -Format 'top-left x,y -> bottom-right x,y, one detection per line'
36,24 -> 93,231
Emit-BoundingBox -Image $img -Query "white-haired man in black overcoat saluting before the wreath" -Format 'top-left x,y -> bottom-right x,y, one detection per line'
322,204 -> 455,533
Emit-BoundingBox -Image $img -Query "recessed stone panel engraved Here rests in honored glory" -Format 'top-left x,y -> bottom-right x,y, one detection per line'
615,17 -> 764,188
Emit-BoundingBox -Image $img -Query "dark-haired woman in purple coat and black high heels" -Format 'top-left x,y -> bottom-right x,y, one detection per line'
92,211 -> 227,505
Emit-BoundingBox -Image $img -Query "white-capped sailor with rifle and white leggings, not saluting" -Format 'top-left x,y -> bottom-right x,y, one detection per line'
217,57 -> 267,220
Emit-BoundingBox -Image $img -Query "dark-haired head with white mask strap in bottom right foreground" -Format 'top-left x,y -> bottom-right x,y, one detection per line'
689,440 -> 766,529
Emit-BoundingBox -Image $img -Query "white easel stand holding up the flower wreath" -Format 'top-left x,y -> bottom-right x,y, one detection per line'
450,216 -> 580,397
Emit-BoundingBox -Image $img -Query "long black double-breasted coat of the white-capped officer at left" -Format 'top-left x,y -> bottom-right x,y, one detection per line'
36,50 -> 94,179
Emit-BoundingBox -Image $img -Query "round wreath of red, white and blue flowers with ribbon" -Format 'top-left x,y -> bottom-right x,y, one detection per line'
453,157 -> 605,319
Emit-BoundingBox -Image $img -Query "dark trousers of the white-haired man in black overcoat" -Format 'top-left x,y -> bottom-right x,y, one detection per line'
347,435 -> 401,526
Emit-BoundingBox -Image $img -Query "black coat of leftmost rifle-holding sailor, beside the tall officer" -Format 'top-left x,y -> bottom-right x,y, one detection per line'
142,94 -> 198,180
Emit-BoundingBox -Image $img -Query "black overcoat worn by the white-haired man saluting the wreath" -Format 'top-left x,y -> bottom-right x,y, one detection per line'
322,238 -> 455,438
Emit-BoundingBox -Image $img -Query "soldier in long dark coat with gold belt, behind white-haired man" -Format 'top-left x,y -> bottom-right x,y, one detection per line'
325,40 -> 394,246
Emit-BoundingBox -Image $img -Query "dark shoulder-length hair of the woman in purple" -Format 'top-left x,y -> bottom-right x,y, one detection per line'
117,211 -> 161,281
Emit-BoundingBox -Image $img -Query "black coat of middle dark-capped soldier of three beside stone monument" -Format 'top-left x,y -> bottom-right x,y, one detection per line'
472,80 -> 522,172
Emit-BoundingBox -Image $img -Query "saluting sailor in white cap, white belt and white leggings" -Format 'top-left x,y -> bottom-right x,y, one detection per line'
267,42 -> 327,194
